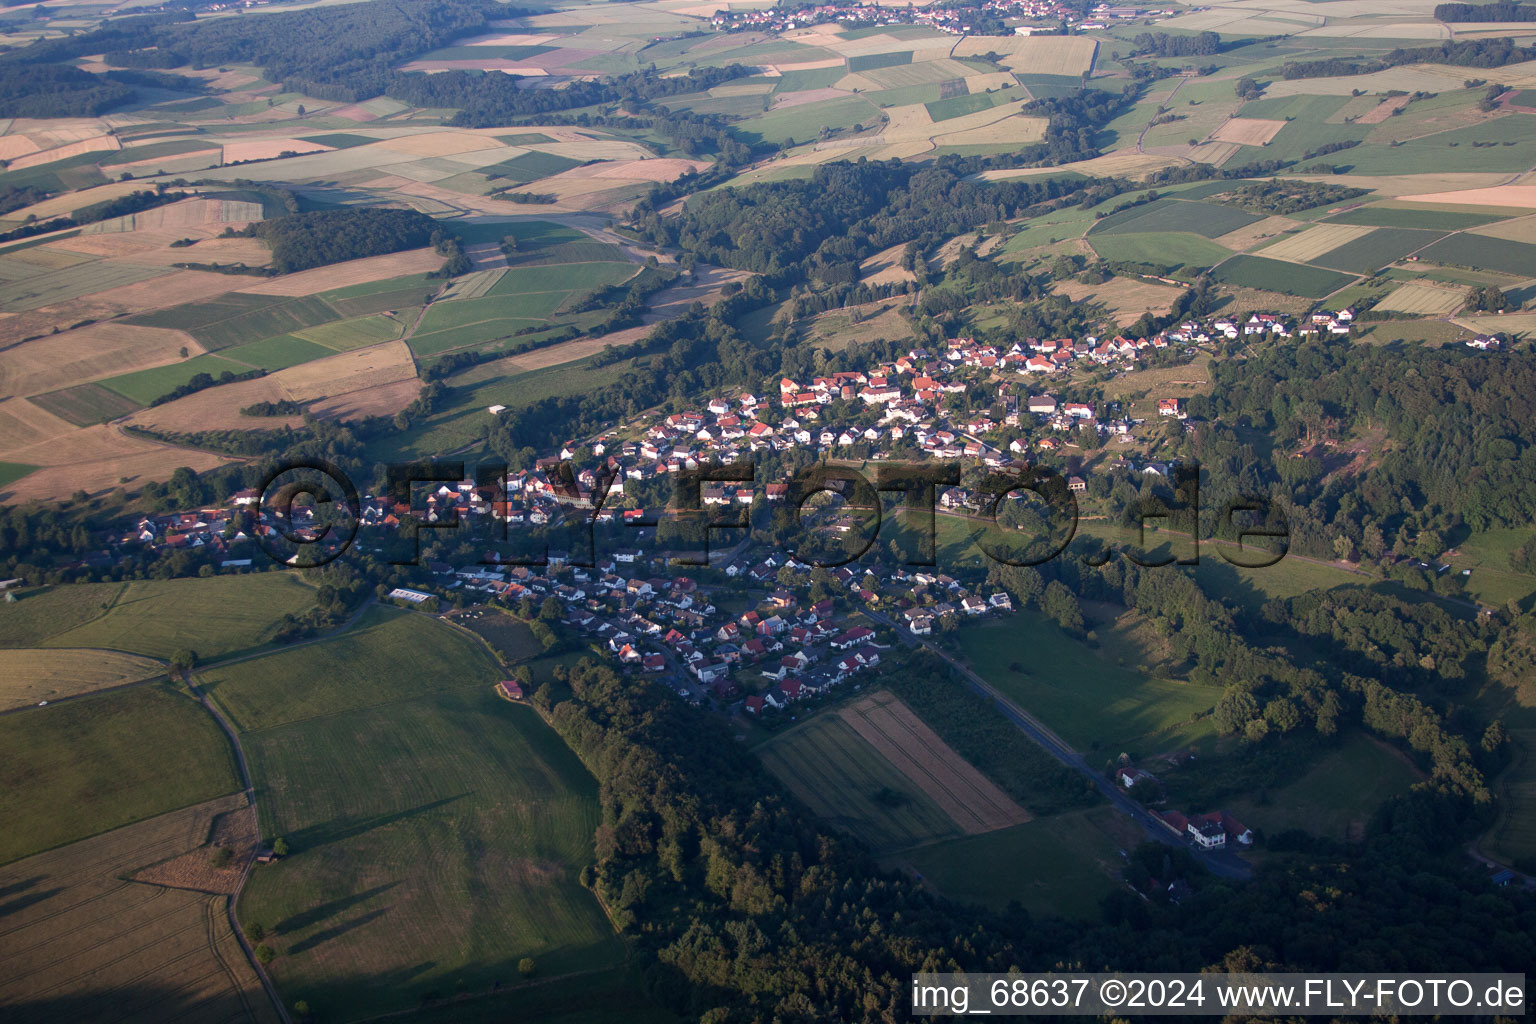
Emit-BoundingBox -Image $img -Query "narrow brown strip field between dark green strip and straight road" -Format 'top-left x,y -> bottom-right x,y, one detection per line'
837,692 -> 1031,835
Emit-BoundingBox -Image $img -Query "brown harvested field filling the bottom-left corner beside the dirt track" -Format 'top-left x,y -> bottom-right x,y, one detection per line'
0,795 -> 278,1024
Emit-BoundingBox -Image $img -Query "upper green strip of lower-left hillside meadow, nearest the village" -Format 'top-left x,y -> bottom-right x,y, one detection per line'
198,606 -> 502,731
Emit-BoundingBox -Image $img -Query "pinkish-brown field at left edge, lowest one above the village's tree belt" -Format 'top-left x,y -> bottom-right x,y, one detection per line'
0,424 -> 229,502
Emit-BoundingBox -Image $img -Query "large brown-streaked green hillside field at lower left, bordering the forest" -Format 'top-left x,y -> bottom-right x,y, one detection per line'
240,681 -> 624,1016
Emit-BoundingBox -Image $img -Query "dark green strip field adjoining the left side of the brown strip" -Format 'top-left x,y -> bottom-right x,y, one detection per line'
757,715 -> 962,851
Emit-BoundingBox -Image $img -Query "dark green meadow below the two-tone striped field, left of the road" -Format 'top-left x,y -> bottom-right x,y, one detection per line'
900,808 -> 1137,920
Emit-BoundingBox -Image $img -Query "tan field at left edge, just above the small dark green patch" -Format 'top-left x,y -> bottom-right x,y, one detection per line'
0,324 -> 203,398
